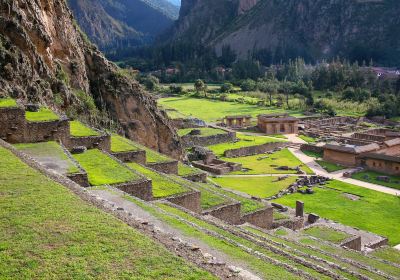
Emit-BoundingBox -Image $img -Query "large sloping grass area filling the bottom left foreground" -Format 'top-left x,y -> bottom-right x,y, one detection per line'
0,148 -> 214,279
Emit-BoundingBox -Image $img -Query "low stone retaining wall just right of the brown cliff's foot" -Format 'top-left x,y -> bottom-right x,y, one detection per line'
181,131 -> 236,148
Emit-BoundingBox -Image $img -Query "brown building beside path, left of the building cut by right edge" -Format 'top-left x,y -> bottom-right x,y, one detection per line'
323,143 -> 380,167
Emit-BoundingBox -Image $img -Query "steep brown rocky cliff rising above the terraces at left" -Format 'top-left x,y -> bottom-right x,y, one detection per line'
0,0 -> 180,157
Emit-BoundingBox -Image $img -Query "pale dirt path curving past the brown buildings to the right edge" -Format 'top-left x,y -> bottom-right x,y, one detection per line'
289,148 -> 400,196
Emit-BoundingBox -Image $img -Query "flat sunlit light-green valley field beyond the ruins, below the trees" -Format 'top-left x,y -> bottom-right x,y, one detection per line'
158,97 -> 301,122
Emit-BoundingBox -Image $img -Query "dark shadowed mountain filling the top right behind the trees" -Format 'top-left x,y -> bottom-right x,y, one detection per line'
170,0 -> 400,65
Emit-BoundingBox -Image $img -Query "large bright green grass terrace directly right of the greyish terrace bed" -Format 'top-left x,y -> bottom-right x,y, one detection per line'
73,149 -> 140,186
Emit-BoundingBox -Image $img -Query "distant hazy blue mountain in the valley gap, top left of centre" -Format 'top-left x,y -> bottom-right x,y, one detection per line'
68,0 -> 179,52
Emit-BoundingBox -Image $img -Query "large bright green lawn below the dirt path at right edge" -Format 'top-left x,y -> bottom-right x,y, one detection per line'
275,181 -> 400,245
